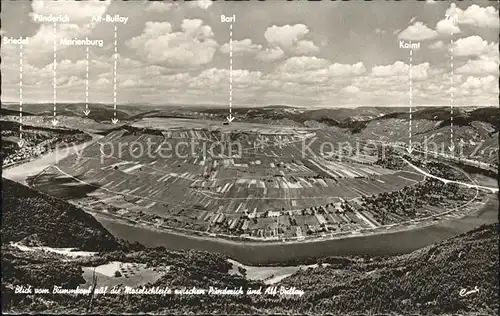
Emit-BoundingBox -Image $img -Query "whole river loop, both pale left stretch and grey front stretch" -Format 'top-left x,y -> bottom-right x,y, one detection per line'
4,134 -> 498,265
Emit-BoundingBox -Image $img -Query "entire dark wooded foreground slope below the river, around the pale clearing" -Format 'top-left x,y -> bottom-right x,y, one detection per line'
2,180 -> 498,315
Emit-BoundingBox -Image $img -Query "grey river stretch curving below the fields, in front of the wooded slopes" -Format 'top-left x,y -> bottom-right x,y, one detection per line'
93,195 -> 498,265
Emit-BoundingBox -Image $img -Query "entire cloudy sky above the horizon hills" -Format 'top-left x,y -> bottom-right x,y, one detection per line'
1,0 -> 499,108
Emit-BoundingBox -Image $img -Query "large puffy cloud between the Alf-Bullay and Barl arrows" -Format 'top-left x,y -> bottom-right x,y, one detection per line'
127,19 -> 219,68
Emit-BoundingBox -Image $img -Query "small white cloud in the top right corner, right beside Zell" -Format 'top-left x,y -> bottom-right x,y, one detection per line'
446,3 -> 500,28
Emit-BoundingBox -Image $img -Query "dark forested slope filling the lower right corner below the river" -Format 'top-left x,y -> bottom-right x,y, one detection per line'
282,223 -> 499,315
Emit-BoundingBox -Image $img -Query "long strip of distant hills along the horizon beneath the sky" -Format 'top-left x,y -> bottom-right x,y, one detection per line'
2,103 -> 500,133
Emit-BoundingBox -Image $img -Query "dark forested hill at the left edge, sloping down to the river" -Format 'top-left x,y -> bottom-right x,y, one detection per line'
2,178 -> 119,251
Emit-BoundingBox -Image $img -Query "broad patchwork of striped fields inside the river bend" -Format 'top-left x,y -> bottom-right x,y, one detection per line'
29,118 -> 480,241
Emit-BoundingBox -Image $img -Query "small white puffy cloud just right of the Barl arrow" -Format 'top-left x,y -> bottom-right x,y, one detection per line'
264,24 -> 319,55
